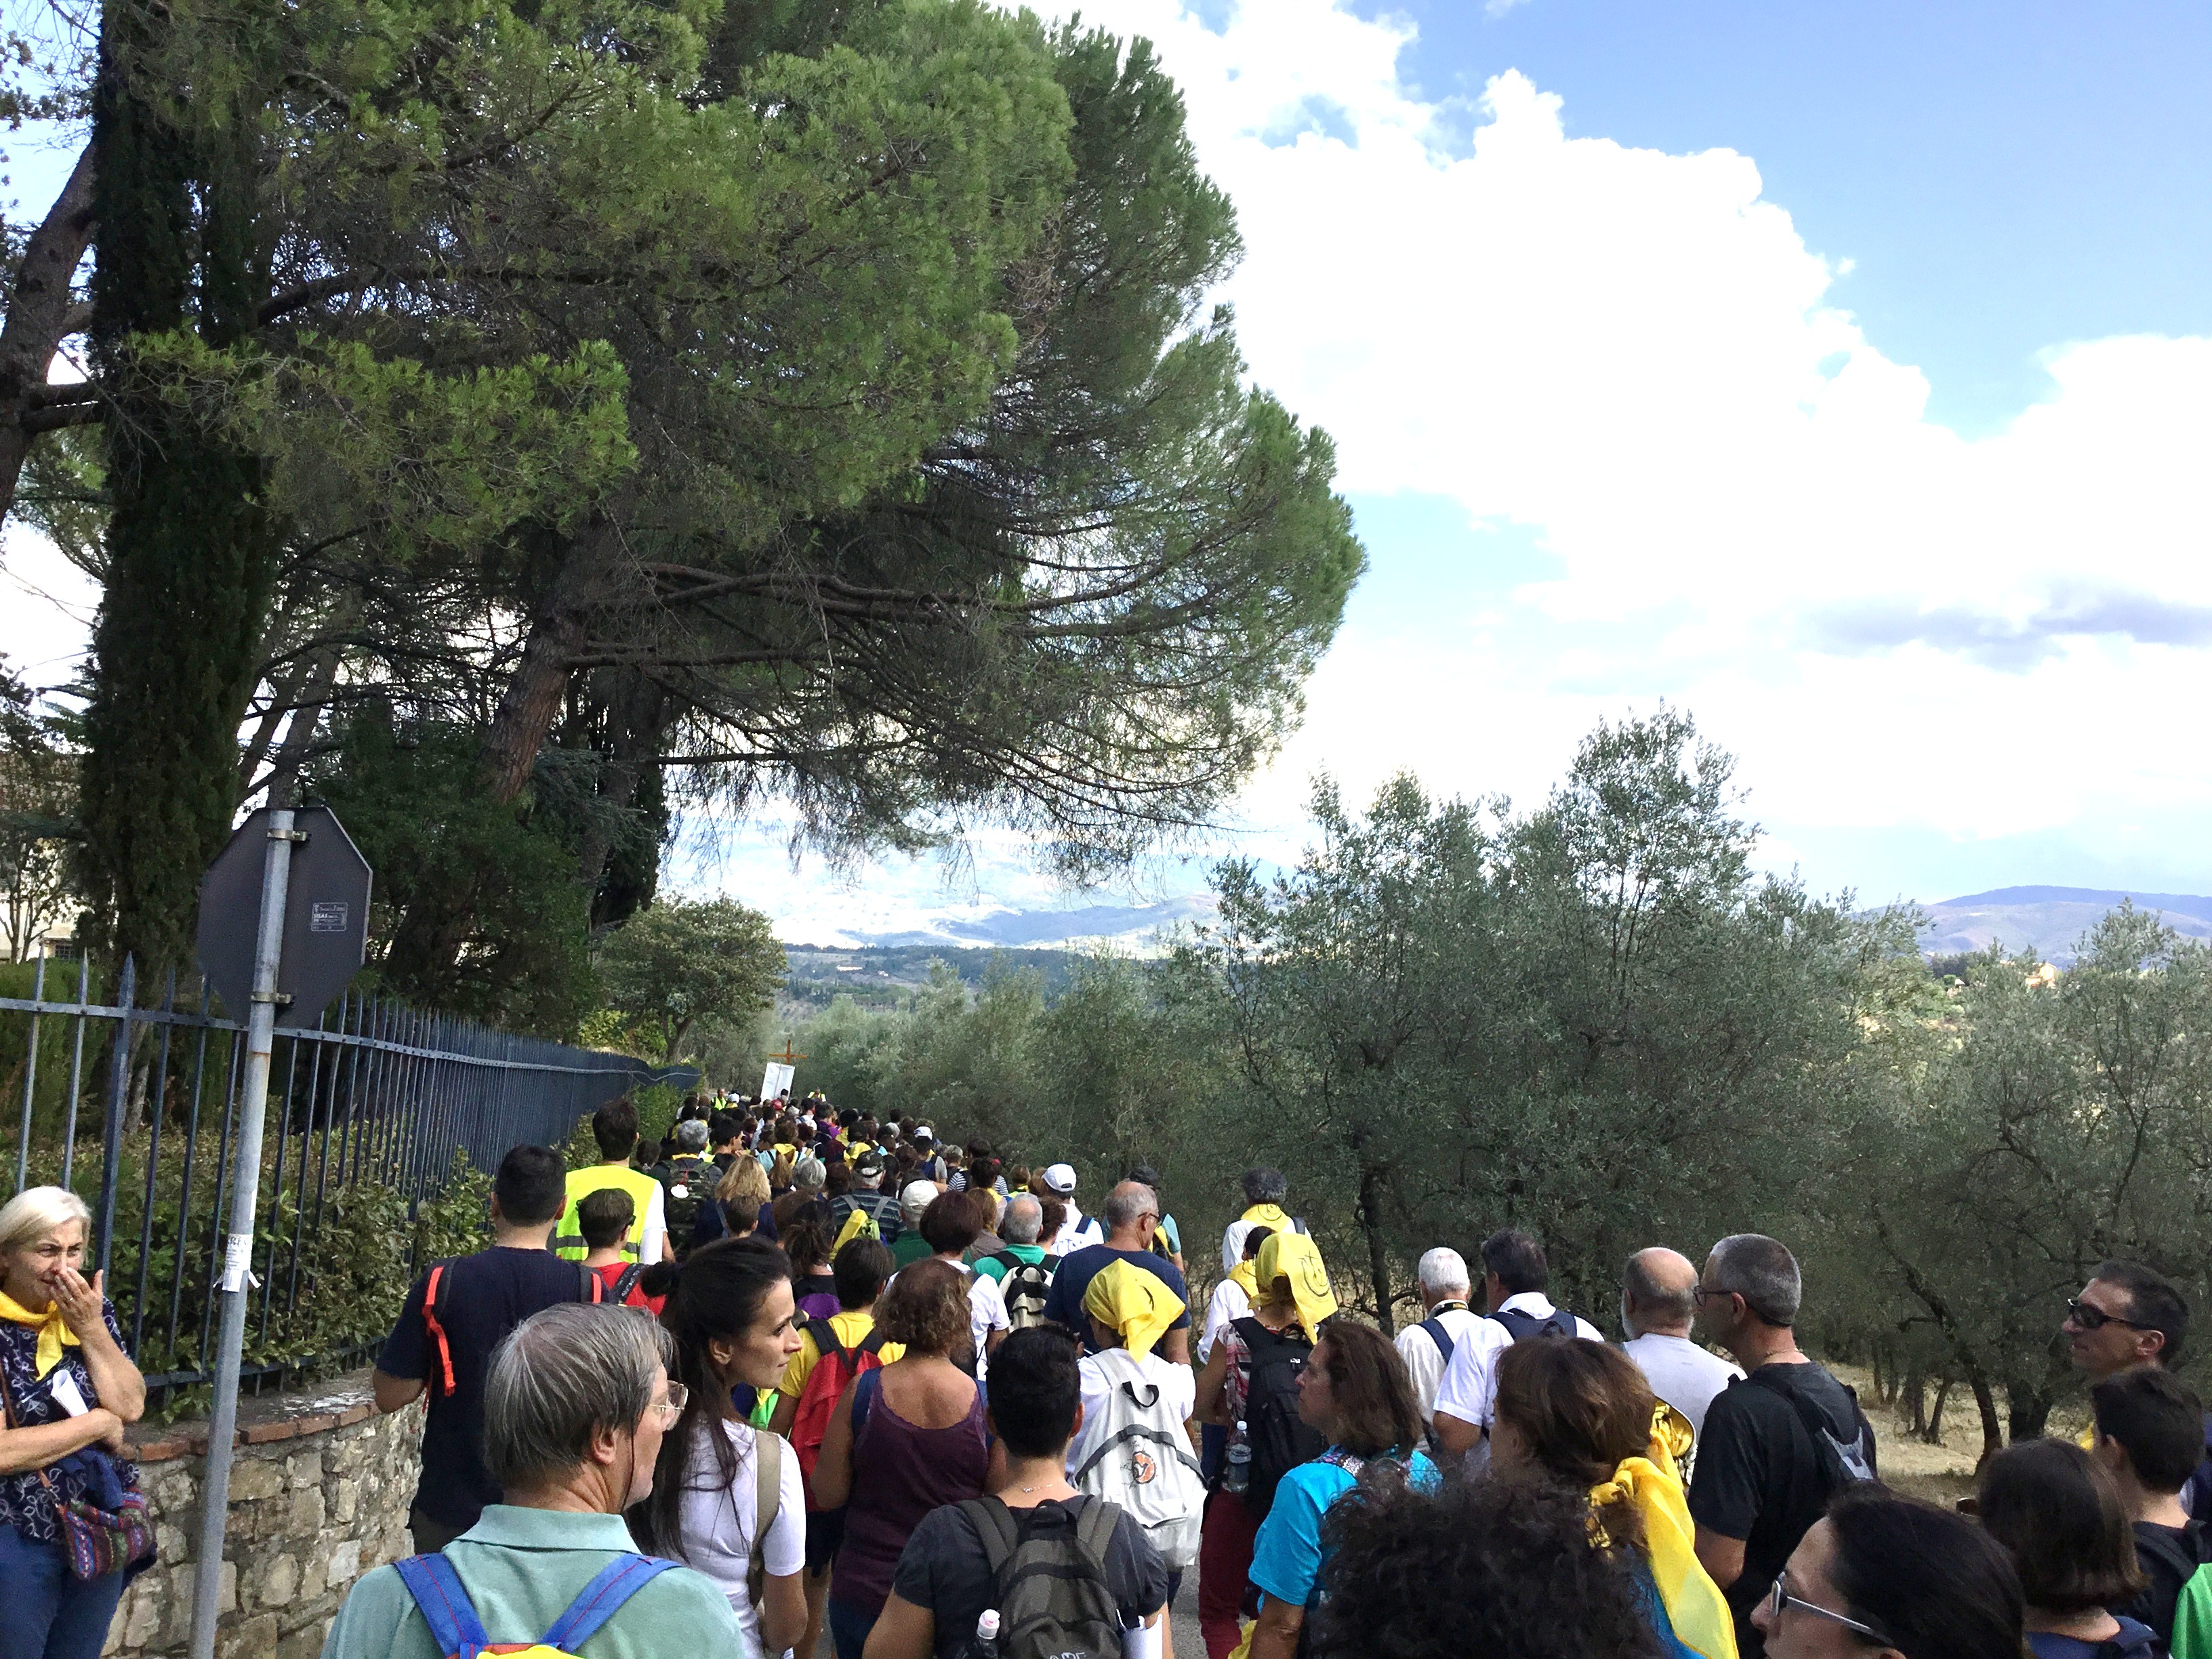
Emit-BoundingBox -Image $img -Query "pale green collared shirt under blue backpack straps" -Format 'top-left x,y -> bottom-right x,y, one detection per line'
323,1504 -> 747,1659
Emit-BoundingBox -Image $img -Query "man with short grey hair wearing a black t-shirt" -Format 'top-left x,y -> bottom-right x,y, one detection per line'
1690,1232 -> 1876,1659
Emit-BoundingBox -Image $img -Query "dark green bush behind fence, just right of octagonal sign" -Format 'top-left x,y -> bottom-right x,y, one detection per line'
314,714 -> 597,1038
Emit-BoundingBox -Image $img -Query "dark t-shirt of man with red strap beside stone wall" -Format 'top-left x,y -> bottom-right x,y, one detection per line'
376,1246 -> 588,1528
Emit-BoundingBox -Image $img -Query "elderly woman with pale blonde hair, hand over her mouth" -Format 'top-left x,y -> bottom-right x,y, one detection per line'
0,1186 -> 146,1659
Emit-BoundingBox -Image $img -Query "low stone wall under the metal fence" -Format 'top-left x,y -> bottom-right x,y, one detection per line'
102,1372 -> 422,1659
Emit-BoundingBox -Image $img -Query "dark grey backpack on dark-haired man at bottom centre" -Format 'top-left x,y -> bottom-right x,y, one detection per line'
960,1498 -> 1122,1659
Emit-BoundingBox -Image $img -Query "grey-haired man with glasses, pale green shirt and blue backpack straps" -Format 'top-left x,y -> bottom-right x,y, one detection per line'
323,1305 -> 747,1659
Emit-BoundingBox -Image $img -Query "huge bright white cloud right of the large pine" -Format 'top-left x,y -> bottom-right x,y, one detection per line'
1044,0 -> 2212,896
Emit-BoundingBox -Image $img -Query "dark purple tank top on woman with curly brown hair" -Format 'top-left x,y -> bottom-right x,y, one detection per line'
830,1372 -> 991,1617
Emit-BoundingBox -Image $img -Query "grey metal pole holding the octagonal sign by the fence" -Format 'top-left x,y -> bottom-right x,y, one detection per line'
188,812 -> 292,1659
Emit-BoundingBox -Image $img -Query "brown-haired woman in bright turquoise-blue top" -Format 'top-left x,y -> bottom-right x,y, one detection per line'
1250,1318 -> 1438,1659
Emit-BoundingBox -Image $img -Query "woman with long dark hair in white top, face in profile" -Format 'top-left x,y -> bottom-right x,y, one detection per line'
628,1239 -> 807,1659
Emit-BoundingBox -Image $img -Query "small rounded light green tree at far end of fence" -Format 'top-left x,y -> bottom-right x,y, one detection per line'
600,898 -> 783,1059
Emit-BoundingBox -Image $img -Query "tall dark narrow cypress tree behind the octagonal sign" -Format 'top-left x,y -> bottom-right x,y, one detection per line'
82,0 -> 276,987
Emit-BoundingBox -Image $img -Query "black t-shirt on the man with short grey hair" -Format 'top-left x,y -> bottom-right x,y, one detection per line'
1690,1365 -> 1871,1659
